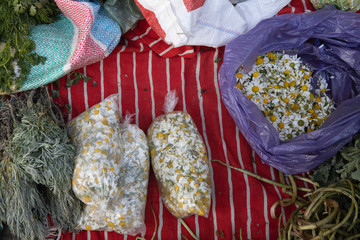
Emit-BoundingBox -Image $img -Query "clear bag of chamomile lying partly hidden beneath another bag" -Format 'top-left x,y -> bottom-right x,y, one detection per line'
79,118 -> 150,235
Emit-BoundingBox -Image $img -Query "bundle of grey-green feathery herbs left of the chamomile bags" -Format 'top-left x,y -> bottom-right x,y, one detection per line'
0,88 -> 81,240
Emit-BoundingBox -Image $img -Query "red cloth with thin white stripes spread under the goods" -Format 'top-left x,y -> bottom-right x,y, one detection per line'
55,0 -> 313,240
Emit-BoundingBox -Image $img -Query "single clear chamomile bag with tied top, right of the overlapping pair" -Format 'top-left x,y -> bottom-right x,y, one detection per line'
148,92 -> 211,218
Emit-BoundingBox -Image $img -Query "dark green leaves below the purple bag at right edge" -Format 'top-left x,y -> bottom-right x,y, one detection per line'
312,133 -> 360,186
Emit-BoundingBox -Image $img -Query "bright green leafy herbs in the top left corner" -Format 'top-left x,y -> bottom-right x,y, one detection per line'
0,0 -> 60,93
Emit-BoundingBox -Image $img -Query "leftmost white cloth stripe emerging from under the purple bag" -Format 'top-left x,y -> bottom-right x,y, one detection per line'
236,127 -> 252,239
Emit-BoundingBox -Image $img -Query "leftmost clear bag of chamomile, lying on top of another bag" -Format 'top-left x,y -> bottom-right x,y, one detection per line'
68,96 -> 124,205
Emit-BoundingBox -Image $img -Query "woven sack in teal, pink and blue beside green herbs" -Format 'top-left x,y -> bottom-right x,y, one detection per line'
20,0 -> 121,91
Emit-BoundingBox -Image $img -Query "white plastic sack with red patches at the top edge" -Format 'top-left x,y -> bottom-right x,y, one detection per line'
135,0 -> 290,47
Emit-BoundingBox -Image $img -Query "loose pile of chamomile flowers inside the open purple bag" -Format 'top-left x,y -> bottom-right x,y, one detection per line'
236,52 -> 335,141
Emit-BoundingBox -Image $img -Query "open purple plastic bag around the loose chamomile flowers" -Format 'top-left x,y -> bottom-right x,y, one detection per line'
219,9 -> 360,174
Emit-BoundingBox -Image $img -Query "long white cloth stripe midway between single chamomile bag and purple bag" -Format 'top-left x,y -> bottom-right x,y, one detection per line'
214,49 -> 235,235
